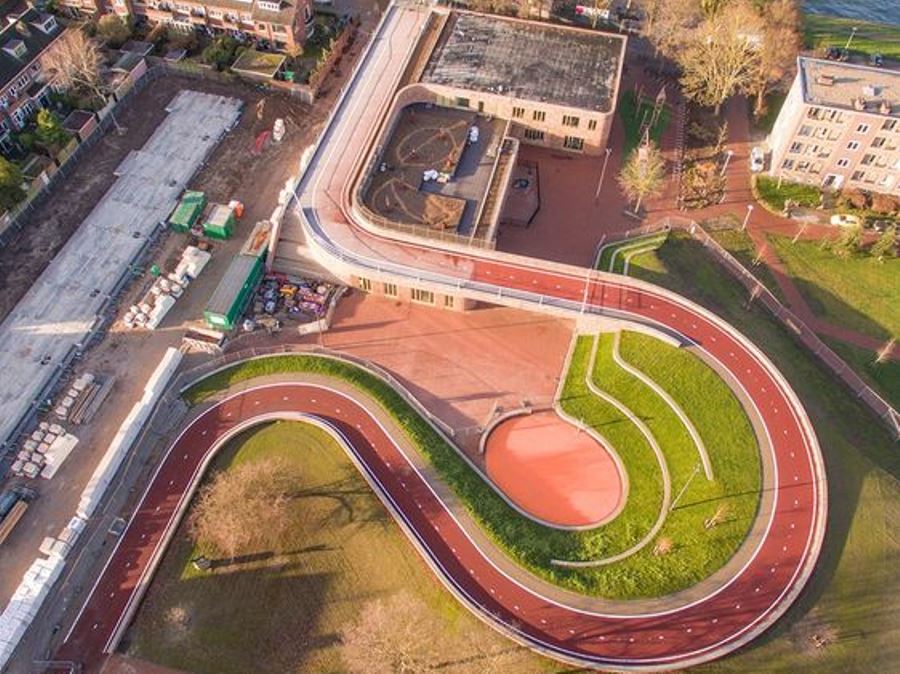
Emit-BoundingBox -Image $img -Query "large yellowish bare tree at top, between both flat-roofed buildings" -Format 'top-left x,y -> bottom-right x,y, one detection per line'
677,0 -> 763,115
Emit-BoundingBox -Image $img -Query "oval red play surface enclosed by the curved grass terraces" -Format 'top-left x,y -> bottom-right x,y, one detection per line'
484,411 -> 623,527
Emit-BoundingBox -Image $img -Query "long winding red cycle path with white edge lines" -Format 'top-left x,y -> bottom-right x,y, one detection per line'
57,10 -> 825,671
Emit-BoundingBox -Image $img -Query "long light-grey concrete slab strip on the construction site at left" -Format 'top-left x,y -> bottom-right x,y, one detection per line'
0,86 -> 241,443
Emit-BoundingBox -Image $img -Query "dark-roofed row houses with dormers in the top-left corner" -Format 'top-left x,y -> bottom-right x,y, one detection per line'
0,9 -> 65,147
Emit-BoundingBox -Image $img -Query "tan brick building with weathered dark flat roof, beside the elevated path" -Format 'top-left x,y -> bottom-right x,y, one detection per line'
417,12 -> 626,155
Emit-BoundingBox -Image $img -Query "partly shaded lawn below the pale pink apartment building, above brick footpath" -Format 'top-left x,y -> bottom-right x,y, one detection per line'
769,236 -> 900,341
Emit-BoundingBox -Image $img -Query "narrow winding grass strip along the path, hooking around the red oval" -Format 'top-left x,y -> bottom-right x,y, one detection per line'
185,338 -> 764,599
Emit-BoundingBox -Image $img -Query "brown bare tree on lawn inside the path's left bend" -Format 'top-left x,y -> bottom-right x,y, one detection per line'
190,459 -> 298,558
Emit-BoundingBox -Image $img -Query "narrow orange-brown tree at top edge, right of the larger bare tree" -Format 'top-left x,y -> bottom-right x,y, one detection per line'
748,0 -> 802,117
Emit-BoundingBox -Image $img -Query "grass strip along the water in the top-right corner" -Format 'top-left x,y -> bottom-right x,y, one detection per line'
803,13 -> 900,60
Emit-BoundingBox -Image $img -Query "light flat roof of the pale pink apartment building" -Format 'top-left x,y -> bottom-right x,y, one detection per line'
797,56 -> 900,117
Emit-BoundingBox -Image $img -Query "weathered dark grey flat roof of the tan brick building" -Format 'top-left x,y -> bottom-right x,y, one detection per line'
422,12 -> 625,112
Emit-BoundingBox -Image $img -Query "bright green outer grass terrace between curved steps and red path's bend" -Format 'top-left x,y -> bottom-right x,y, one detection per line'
581,332 -> 760,594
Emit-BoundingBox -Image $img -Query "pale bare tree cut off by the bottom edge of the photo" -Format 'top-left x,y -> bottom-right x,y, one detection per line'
341,591 -> 446,674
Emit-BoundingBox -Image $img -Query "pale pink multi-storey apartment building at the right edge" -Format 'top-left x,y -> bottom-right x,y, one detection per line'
768,57 -> 900,195
